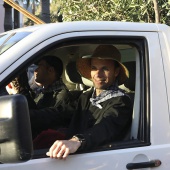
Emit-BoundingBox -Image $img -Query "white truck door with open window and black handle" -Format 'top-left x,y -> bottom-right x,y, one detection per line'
0,31 -> 170,170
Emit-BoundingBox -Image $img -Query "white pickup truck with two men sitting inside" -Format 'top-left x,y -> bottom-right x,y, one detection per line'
0,21 -> 170,170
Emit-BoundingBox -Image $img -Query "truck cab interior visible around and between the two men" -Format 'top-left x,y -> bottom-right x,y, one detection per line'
32,43 -> 143,158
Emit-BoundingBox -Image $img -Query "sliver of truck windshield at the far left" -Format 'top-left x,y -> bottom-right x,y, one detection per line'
0,32 -> 31,54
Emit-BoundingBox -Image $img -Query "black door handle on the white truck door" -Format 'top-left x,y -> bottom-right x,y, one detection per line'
126,160 -> 161,169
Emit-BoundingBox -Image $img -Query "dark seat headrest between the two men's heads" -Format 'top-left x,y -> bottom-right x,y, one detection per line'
65,61 -> 83,84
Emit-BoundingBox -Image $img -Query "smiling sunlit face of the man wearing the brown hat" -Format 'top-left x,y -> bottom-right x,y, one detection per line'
91,58 -> 119,90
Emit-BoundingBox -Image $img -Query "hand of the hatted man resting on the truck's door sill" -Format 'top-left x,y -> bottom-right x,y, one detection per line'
46,138 -> 81,159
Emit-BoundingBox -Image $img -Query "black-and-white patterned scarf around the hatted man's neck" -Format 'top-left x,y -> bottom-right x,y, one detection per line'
90,83 -> 125,109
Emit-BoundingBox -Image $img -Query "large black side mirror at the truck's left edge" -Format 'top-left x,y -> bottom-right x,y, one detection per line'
0,94 -> 33,163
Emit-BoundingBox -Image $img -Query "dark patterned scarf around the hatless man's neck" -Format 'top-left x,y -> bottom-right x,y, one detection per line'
41,79 -> 67,93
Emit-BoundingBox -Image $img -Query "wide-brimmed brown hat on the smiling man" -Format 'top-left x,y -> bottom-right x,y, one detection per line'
77,45 -> 129,85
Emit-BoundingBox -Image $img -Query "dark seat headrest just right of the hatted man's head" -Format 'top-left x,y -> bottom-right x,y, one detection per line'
123,61 -> 136,91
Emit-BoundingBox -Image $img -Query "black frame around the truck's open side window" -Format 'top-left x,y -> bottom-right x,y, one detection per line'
0,35 -> 150,158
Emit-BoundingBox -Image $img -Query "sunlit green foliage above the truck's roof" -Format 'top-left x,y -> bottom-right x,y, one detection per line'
51,0 -> 170,25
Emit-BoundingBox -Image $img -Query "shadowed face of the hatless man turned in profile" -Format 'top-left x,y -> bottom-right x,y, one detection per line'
34,60 -> 49,85
